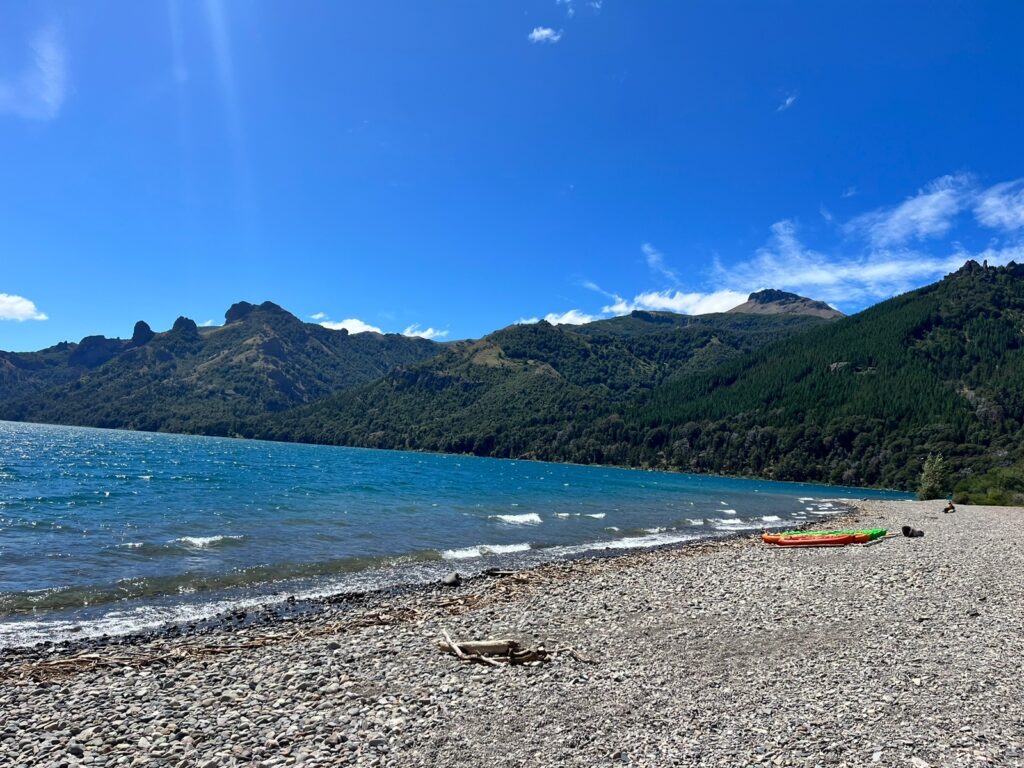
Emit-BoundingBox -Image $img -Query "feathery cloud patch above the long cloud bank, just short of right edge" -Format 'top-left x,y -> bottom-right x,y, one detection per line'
846,174 -> 973,248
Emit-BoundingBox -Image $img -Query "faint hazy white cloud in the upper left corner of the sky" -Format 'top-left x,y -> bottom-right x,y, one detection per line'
0,25 -> 68,120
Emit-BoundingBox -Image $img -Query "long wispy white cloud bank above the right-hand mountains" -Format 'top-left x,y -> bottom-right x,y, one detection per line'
561,174 -> 1024,321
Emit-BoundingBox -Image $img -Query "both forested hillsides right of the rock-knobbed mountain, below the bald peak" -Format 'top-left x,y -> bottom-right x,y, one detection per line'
260,263 -> 1024,489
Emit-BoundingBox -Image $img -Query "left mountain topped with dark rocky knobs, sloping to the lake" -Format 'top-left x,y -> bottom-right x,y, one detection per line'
0,302 -> 438,434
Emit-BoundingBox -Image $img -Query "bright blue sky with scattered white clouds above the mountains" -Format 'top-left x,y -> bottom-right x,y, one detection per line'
0,0 -> 1024,350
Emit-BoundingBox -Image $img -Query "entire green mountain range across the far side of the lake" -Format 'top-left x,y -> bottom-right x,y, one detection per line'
0,270 -> 1024,499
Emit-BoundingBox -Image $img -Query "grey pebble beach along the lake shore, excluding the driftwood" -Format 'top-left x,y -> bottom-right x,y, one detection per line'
0,502 -> 1024,768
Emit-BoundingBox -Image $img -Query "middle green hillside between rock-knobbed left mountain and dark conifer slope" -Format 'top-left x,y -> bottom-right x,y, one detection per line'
256,312 -> 823,462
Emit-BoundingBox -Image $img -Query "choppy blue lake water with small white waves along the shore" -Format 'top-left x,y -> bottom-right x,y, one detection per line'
0,422 -> 906,646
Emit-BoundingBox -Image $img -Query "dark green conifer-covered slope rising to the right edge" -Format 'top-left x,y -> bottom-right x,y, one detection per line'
622,262 -> 1024,488
